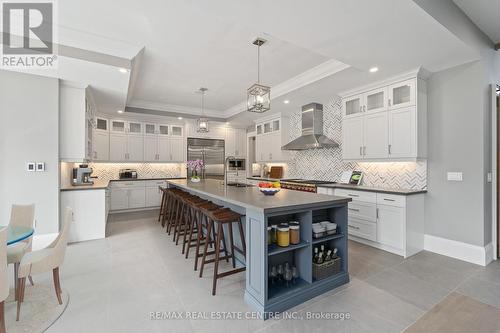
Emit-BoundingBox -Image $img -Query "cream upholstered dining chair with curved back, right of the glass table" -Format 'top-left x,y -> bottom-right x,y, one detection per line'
16,207 -> 73,321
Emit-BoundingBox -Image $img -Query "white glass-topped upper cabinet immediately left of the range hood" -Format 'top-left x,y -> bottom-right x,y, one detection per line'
255,115 -> 290,163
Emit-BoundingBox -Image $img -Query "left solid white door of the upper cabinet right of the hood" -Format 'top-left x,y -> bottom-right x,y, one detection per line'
342,117 -> 364,160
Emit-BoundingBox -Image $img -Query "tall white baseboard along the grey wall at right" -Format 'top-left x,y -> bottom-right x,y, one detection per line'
424,235 -> 493,266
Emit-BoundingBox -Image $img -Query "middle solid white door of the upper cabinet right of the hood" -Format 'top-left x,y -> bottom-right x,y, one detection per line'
363,112 -> 389,158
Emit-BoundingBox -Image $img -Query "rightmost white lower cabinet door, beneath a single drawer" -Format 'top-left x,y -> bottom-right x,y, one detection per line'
377,205 -> 405,249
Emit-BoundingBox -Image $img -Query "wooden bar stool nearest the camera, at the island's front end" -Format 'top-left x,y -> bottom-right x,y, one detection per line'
200,208 -> 246,295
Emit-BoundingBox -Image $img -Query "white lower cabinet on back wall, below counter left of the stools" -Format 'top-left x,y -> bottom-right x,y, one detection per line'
111,180 -> 166,211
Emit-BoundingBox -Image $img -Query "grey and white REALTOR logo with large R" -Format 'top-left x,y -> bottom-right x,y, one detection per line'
1,0 -> 57,68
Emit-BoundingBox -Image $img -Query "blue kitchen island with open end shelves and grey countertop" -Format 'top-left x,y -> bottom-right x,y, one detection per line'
167,179 -> 351,317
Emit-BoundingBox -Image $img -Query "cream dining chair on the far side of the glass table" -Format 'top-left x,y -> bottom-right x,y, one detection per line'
7,205 -> 35,300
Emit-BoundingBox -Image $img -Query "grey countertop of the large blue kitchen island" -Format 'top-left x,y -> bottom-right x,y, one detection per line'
167,179 -> 351,213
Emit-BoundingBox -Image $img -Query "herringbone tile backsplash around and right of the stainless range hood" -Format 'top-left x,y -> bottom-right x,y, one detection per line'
286,98 -> 427,189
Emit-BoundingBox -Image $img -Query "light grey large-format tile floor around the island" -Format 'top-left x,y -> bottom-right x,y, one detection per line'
27,211 -> 500,333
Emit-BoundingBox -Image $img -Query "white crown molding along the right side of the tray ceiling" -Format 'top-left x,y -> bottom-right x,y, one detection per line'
224,59 -> 351,117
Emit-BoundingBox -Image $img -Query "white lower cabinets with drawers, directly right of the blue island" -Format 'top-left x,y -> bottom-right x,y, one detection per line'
318,187 -> 424,258
